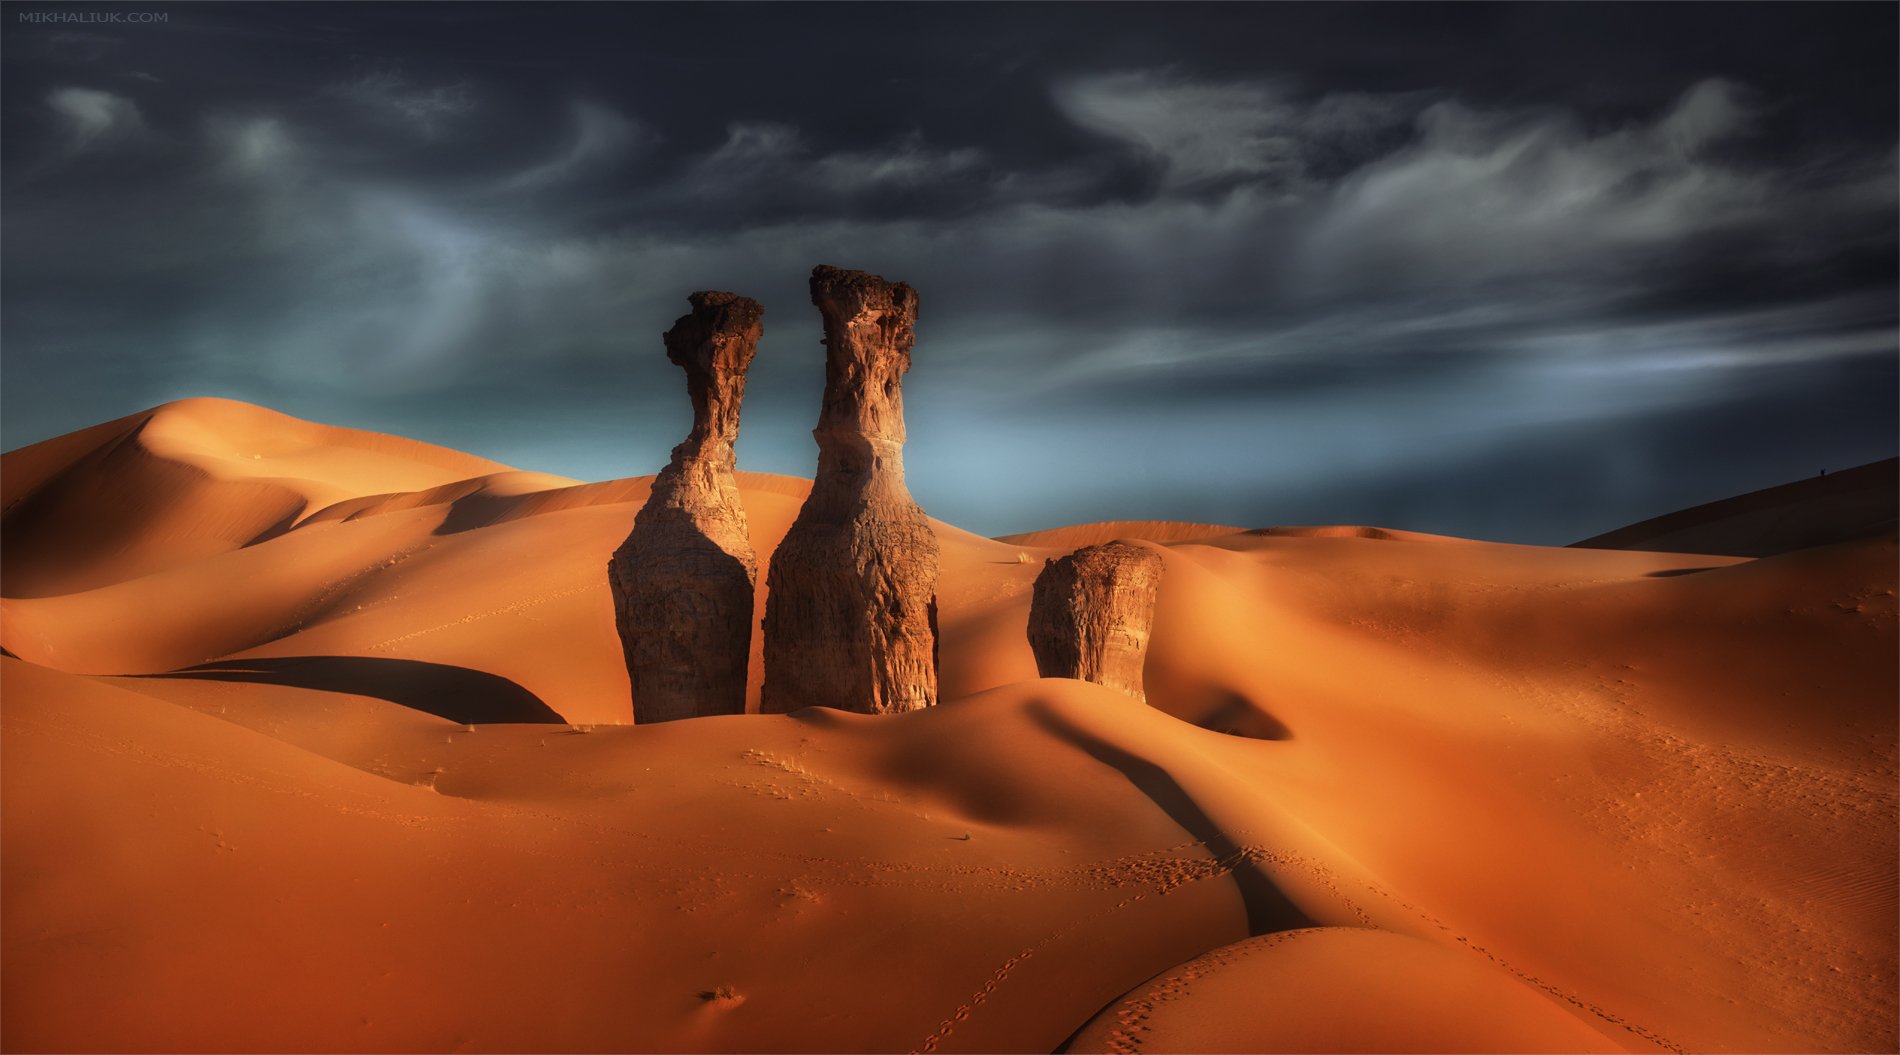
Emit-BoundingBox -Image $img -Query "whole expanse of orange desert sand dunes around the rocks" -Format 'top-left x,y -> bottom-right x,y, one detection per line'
0,399 -> 1900,1051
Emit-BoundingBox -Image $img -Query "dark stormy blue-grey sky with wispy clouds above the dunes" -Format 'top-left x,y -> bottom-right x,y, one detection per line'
0,0 -> 1900,544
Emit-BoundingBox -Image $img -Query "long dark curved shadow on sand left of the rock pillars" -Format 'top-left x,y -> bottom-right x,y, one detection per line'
139,656 -> 564,724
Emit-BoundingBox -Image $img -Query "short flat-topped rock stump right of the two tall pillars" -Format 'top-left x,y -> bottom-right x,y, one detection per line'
1030,542 -> 1163,701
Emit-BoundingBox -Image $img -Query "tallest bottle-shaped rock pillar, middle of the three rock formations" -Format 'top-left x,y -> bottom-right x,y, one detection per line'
760,264 -> 937,715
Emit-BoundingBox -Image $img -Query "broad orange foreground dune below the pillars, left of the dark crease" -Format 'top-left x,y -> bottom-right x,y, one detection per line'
0,660 -> 1345,1051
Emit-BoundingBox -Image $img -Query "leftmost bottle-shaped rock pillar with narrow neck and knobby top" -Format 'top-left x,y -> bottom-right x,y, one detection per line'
608,293 -> 764,724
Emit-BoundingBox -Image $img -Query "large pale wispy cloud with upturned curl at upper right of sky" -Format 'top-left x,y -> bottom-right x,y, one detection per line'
1305,80 -> 1778,285
